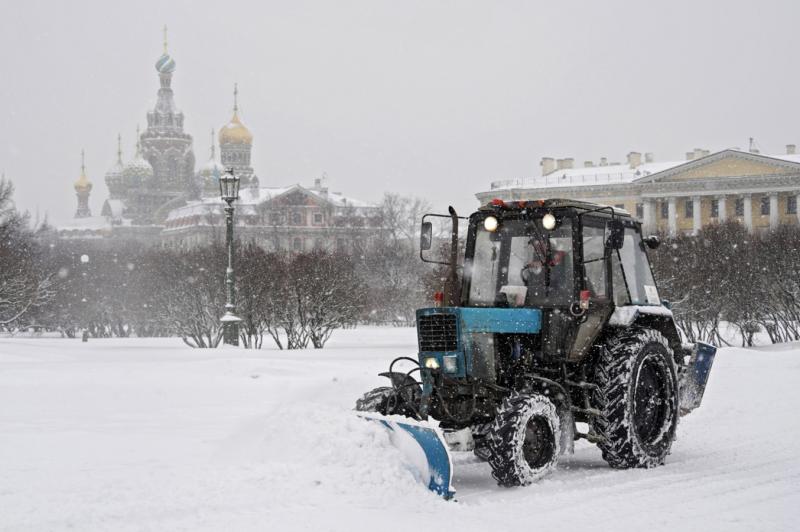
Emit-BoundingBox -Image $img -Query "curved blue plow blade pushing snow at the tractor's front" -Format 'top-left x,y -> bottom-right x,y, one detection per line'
358,412 -> 456,499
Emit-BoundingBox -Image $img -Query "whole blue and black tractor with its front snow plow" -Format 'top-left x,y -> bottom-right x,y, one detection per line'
356,199 -> 716,496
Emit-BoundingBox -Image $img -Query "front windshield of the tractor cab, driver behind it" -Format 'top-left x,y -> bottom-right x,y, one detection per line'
464,218 -> 574,307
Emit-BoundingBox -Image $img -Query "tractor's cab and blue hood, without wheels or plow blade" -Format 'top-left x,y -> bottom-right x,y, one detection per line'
417,200 -> 668,404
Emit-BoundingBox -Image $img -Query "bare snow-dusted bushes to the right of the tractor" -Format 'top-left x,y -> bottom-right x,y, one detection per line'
650,222 -> 800,346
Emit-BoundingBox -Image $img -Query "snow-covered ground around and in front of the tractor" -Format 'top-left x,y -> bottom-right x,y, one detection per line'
0,328 -> 800,532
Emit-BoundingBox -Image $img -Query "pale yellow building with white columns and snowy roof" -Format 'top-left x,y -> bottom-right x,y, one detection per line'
477,144 -> 800,235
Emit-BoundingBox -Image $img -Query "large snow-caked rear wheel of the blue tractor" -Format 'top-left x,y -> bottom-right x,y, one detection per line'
593,328 -> 678,469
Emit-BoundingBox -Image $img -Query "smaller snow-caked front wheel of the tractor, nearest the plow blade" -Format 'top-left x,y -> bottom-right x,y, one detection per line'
486,392 -> 560,487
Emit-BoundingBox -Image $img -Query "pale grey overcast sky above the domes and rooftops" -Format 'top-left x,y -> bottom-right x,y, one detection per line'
0,0 -> 800,220
